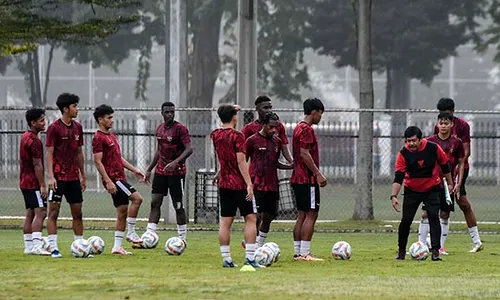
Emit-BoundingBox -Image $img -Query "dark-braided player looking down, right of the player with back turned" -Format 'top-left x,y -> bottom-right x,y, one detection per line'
246,112 -> 293,247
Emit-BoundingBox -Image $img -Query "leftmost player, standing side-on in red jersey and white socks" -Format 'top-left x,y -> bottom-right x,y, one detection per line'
19,108 -> 50,255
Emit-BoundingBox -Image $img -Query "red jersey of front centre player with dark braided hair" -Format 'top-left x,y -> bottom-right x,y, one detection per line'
245,133 -> 283,192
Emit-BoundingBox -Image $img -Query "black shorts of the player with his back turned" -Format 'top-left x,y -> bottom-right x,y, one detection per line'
219,189 -> 257,217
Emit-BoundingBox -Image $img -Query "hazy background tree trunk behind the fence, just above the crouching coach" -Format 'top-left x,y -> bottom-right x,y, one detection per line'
386,67 -> 411,169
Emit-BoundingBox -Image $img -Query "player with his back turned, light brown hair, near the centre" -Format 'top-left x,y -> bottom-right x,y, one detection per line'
210,105 -> 263,268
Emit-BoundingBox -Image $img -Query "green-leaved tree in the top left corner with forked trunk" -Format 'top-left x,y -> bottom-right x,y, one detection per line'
0,0 -> 140,106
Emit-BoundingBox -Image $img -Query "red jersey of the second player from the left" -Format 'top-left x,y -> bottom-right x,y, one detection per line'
46,119 -> 83,181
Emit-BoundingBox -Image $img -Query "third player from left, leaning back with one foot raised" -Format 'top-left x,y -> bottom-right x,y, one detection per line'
92,104 -> 145,255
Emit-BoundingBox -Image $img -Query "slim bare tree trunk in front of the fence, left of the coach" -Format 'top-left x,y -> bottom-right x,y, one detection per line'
352,0 -> 373,220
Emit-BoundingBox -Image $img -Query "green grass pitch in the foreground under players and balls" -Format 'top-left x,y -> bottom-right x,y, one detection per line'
0,229 -> 500,299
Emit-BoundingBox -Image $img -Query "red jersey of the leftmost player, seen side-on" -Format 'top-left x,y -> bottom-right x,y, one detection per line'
19,130 -> 43,190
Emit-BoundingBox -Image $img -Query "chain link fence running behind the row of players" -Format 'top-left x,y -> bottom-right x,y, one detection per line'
0,108 -> 500,224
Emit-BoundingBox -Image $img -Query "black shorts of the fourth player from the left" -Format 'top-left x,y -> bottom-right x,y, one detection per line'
151,174 -> 186,209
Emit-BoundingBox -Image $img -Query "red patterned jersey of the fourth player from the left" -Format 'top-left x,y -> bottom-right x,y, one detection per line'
155,121 -> 191,176
